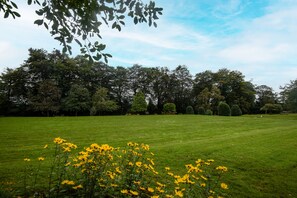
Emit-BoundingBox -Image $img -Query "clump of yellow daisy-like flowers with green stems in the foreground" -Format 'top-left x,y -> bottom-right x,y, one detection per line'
12,138 -> 228,198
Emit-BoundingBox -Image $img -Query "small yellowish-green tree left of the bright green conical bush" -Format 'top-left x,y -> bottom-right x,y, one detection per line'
90,87 -> 118,115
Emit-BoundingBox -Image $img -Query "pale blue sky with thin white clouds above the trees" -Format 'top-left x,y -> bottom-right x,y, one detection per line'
0,0 -> 297,92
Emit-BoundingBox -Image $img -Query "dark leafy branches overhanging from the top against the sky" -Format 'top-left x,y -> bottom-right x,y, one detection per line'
0,0 -> 163,62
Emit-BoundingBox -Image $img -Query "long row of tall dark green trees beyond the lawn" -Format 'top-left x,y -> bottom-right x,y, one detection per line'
0,49 -> 297,116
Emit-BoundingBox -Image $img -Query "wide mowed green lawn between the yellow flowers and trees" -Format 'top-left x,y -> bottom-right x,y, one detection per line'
0,114 -> 297,197
